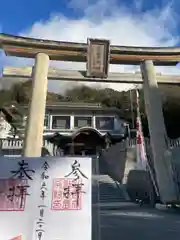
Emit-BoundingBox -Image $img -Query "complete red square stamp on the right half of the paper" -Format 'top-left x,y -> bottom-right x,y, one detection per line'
51,178 -> 84,210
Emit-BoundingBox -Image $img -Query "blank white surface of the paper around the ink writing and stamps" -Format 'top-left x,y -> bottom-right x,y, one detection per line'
0,157 -> 92,240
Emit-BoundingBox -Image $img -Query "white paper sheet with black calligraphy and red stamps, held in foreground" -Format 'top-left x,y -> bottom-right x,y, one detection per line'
0,157 -> 92,240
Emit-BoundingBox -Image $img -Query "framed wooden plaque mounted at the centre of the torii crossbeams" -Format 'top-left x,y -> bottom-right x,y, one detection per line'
86,39 -> 110,78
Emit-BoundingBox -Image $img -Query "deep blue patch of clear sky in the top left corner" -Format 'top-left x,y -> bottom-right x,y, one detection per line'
0,0 -> 70,34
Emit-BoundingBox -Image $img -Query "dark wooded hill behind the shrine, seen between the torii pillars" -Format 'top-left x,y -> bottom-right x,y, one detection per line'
0,81 -> 180,138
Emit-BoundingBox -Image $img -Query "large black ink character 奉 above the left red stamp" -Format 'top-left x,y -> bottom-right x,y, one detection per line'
11,160 -> 35,180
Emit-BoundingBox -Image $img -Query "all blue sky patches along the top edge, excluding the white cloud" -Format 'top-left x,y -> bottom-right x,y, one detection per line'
0,0 -> 180,37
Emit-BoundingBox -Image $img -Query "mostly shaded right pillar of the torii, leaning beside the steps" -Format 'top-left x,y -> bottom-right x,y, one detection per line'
141,60 -> 177,203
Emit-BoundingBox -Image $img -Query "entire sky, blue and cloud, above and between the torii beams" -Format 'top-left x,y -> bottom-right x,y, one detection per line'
0,0 -> 180,93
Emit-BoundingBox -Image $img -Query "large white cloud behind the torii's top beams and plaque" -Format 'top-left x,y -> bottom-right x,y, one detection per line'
0,0 -> 180,92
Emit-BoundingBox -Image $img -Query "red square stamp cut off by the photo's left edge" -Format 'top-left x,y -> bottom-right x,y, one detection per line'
0,179 -> 29,211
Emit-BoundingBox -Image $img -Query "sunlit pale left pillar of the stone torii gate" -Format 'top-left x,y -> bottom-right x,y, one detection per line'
23,53 -> 49,157
